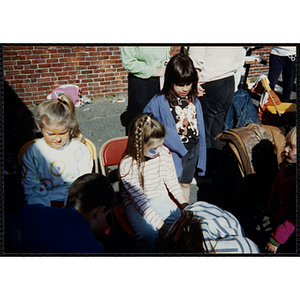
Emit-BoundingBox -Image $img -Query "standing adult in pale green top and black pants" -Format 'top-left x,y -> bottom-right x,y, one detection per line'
120,47 -> 171,134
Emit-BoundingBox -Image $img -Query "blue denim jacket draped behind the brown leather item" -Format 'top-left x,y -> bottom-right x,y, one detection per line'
223,89 -> 261,130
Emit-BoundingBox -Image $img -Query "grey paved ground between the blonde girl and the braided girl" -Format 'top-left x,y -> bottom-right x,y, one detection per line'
76,97 -> 198,204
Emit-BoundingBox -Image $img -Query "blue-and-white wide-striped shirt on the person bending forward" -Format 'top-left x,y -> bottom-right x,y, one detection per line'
186,201 -> 259,254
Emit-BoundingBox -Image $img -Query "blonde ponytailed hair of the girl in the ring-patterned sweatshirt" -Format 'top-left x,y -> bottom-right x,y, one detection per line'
35,94 -> 85,143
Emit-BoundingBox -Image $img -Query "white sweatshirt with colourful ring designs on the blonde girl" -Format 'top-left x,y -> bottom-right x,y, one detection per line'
22,138 -> 93,206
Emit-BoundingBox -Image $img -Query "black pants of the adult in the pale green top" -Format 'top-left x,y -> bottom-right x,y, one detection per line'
121,74 -> 160,133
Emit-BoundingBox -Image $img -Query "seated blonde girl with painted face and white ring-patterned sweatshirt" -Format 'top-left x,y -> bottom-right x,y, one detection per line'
21,94 -> 93,207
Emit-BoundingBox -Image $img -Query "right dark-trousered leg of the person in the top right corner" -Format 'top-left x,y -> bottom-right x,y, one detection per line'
281,56 -> 296,102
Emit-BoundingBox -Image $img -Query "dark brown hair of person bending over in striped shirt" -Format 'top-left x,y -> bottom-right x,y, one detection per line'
161,210 -> 214,253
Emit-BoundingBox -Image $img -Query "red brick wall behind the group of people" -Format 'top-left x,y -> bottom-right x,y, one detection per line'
3,45 -> 270,105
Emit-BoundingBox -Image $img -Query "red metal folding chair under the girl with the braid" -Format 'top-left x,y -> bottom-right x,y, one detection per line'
99,137 -> 134,238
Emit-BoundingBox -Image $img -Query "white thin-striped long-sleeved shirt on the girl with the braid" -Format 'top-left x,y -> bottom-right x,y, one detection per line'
120,146 -> 183,229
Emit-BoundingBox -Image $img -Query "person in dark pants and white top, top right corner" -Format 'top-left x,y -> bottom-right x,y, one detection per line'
268,46 -> 296,102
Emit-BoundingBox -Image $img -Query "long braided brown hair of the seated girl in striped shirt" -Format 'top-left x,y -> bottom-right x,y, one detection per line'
121,113 -> 166,189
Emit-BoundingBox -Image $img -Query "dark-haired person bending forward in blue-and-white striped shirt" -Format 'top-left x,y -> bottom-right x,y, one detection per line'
162,201 -> 259,254
